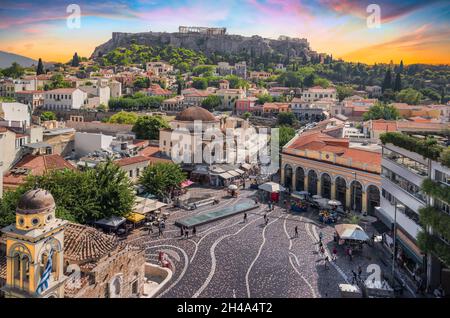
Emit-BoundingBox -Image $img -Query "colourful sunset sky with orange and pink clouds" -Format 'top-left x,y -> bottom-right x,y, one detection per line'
0,0 -> 450,64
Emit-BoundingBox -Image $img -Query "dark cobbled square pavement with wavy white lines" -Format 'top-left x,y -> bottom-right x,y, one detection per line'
128,189 -> 408,298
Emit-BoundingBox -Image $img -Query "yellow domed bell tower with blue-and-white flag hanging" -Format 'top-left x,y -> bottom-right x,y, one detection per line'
2,189 -> 67,298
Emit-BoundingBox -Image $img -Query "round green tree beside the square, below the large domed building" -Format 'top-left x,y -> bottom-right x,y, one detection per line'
139,163 -> 186,199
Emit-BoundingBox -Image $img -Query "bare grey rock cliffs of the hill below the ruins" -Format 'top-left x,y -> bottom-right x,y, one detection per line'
92,32 -> 317,62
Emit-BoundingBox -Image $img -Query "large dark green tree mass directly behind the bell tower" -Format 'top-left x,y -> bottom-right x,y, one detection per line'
0,160 -> 135,226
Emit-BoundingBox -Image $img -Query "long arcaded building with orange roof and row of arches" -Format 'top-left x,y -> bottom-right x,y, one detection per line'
281,130 -> 381,214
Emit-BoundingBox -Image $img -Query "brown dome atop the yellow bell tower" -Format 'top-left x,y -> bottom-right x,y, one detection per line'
16,189 -> 55,214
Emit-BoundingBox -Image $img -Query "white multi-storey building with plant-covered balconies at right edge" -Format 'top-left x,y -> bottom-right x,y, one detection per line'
376,134 -> 450,293
